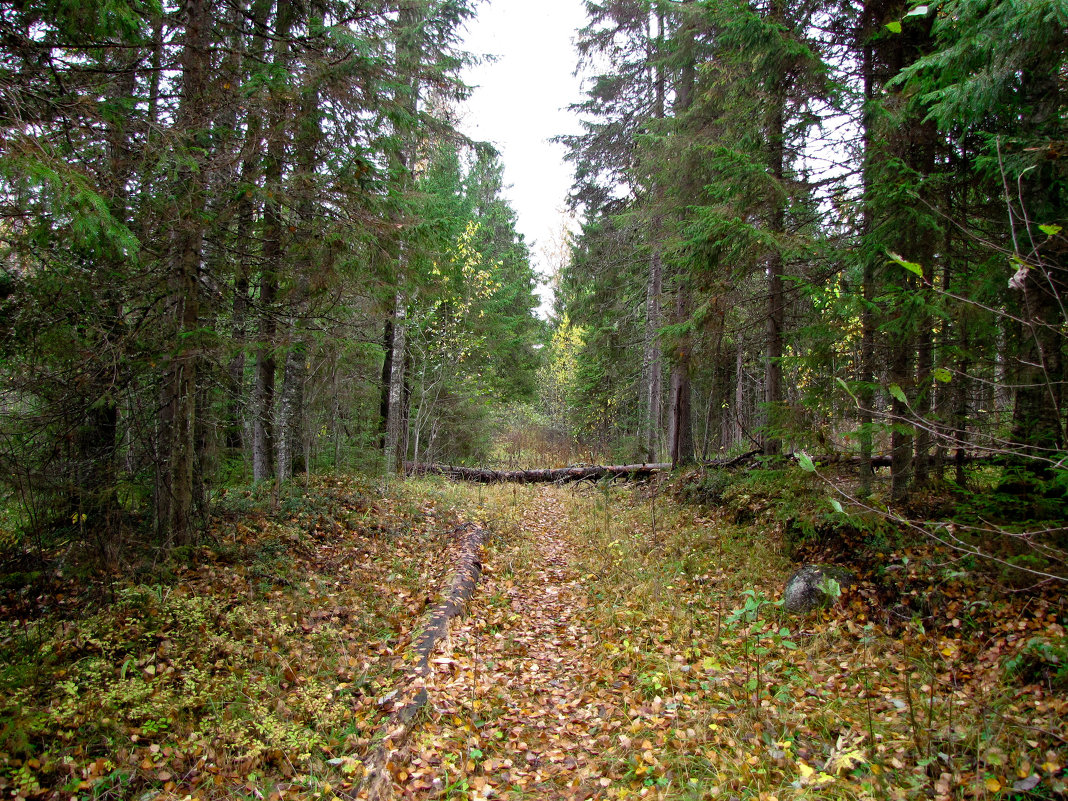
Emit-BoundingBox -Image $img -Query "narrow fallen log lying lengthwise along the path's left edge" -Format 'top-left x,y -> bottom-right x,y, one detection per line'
352,523 -> 489,801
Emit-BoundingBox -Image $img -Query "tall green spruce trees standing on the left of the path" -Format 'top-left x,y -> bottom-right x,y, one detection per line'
0,0 -> 541,562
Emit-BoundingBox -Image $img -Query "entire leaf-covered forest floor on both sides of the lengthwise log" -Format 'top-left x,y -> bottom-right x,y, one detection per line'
0,478 -> 1068,801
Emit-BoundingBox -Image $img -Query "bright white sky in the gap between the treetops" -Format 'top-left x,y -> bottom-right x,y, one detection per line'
460,0 -> 586,301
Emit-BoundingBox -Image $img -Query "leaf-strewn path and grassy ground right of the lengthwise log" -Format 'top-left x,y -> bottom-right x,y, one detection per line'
394,485 -> 1068,801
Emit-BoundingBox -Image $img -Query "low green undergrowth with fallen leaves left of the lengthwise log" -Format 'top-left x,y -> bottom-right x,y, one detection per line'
0,476 -> 472,799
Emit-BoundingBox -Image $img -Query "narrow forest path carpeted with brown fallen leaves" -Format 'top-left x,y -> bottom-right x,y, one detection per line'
394,487 -> 628,799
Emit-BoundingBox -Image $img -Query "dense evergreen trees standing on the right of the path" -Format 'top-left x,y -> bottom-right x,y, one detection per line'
561,0 -> 1068,563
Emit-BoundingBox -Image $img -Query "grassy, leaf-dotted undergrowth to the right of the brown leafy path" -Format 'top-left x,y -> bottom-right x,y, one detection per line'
565,480 -> 1068,799
